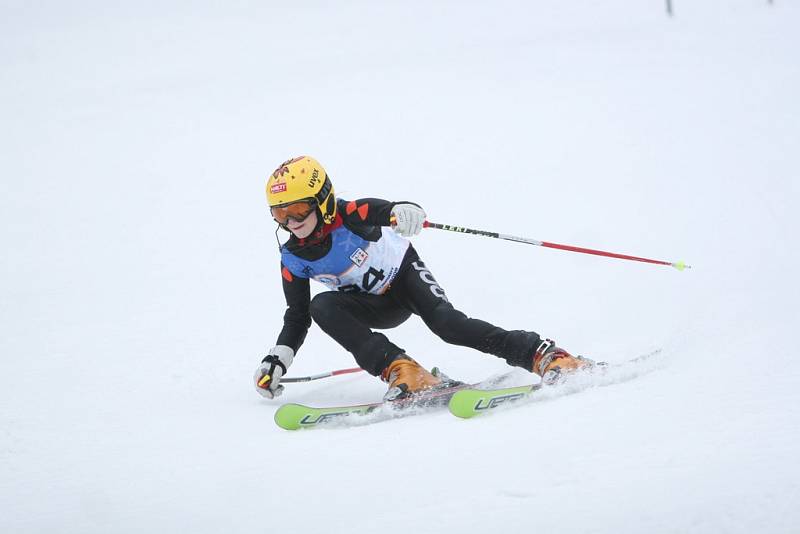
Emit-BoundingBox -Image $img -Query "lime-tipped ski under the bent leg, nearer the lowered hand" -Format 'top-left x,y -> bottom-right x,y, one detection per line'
274,383 -> 472,430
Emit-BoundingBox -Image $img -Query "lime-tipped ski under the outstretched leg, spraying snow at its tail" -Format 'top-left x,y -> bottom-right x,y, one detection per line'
448,349 -> 661,419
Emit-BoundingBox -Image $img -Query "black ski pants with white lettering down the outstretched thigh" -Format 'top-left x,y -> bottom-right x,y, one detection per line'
310,255 -> 541,376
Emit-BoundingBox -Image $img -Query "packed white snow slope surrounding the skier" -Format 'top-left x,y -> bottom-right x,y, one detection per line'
0,0 -> 800,534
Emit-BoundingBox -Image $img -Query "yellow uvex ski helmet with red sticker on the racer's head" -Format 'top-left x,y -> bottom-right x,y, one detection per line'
267,156 -> 336,224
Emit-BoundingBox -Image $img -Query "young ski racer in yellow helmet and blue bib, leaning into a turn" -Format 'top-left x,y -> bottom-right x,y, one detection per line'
254,156 -> 593,400
